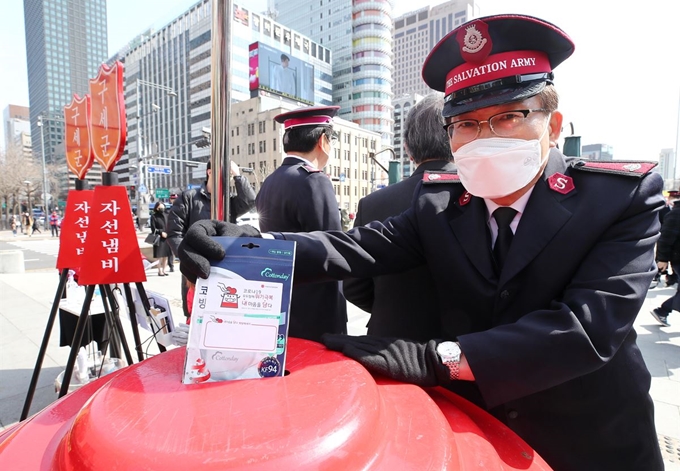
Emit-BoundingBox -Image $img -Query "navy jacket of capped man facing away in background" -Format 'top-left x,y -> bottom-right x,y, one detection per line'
255,157 -> 347,341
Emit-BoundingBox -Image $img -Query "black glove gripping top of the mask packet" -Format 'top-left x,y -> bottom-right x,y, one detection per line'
177,219 -> 262,283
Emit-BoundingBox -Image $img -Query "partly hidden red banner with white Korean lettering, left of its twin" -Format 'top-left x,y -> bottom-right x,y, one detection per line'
57,190 -> 94,273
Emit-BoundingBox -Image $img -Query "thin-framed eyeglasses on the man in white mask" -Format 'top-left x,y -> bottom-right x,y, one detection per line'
444,108 -> 550,144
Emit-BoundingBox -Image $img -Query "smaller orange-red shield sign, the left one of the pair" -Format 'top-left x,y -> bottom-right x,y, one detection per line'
64,94 -> 94,180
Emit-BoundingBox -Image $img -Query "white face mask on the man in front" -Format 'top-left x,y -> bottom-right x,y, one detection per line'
454,119 -> 548,199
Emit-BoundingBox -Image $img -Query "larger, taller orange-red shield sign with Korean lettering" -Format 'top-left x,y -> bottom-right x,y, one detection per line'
90,61 -> 127,172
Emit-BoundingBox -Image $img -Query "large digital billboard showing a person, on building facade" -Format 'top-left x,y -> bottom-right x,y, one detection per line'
249,42 -> 314,104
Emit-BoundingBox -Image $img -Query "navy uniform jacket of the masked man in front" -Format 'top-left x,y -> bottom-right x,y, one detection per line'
282,150 -> 663,471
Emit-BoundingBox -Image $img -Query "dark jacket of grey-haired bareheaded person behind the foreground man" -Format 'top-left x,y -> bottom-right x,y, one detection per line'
343,160 -> 455,341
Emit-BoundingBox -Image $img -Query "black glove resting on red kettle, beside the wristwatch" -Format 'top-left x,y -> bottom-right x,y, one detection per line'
321,334 -> 451,387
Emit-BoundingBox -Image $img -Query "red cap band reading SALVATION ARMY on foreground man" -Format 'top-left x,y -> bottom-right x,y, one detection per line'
445,51 -> 552,95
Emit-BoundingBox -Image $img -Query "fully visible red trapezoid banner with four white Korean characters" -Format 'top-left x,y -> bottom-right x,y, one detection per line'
78,186 -> 146,285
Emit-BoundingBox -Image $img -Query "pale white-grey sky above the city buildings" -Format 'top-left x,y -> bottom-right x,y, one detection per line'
0,0 -> 680,160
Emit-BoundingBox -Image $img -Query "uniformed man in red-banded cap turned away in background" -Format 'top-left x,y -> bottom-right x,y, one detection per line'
255,106 -> 347,341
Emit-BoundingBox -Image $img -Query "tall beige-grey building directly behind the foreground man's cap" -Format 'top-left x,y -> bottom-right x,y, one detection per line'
392,0 -> 480,97
